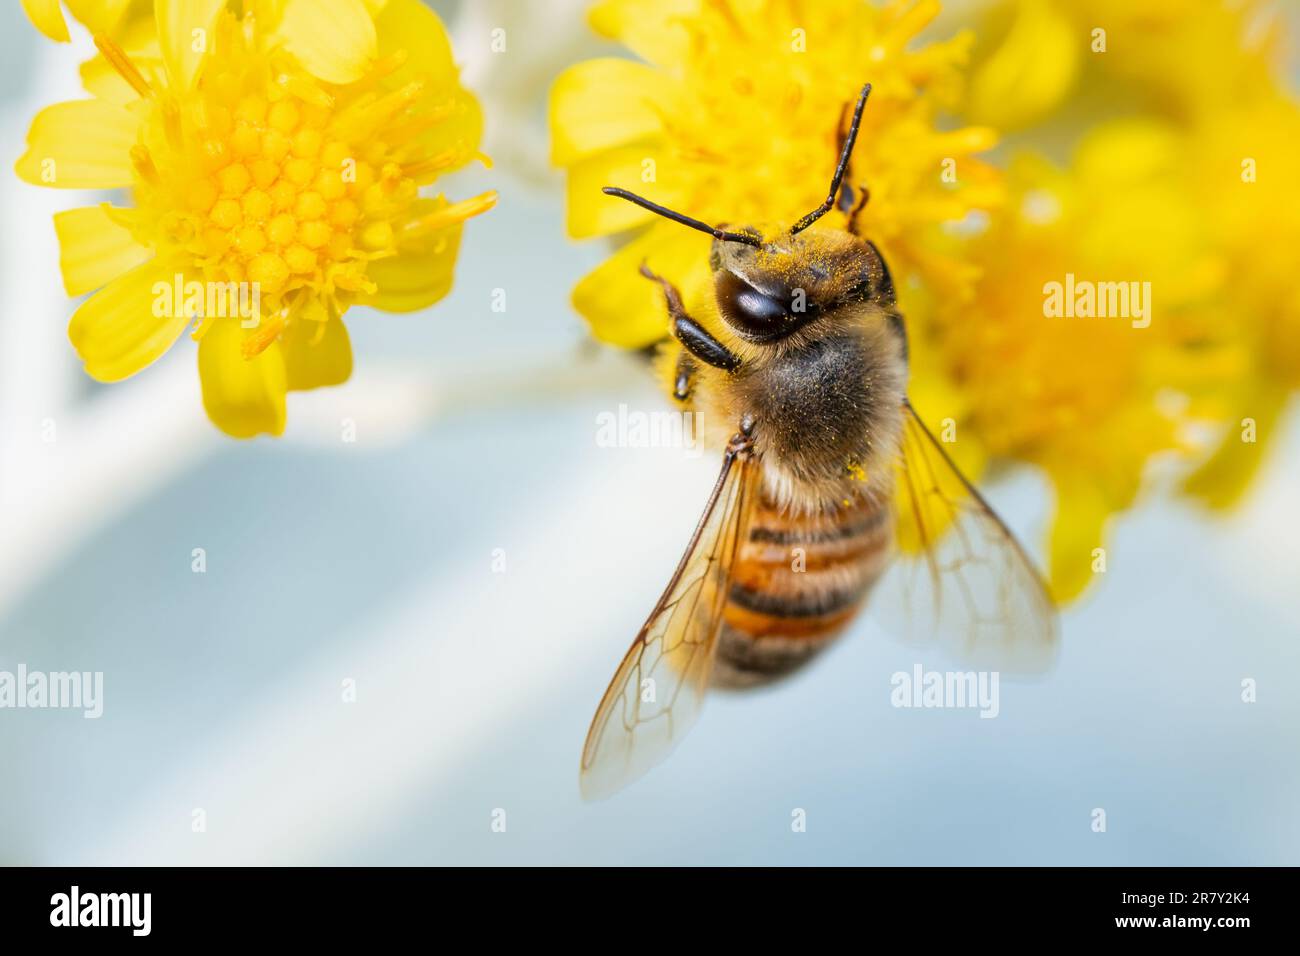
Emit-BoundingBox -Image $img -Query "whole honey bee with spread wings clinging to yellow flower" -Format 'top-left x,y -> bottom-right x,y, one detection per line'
580,83 -> 1057,797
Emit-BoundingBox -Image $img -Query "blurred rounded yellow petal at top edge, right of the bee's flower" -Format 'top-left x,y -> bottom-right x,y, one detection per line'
970,0 -> 1088,129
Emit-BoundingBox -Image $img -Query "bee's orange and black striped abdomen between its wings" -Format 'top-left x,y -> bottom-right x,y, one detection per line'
712,486 -> 893,687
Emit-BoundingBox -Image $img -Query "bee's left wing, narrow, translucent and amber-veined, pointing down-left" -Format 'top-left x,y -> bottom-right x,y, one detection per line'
580,450 -> 759,799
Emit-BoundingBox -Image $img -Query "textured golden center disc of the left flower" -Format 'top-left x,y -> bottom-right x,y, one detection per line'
96,23 -> 495,349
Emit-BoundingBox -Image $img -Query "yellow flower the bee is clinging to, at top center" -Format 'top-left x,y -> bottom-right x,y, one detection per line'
550,0 -> 1000,347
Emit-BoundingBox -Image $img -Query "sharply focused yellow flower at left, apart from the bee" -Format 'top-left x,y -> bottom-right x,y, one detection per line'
16,0 -> 495,437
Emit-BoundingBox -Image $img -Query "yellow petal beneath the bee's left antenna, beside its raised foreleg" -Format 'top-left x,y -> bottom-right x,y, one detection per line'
573,222 -> 709,349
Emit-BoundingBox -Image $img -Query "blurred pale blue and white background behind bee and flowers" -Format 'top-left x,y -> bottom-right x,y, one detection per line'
0,4 -> 1300,865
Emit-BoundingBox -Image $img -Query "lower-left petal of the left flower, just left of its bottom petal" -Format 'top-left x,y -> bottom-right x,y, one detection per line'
68,259 -> 190,381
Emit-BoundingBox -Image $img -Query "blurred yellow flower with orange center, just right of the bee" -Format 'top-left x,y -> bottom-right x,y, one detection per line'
909,132 -> 1242,602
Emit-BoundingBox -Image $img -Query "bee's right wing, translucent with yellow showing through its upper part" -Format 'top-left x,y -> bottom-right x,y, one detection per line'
879,402 -> 1057,674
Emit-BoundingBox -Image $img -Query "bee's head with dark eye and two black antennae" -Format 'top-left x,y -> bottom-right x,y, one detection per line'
605,83 -> 878,343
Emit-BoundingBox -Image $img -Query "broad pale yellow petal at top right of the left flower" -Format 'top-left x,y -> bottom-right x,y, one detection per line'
280,0 -> 378,83
